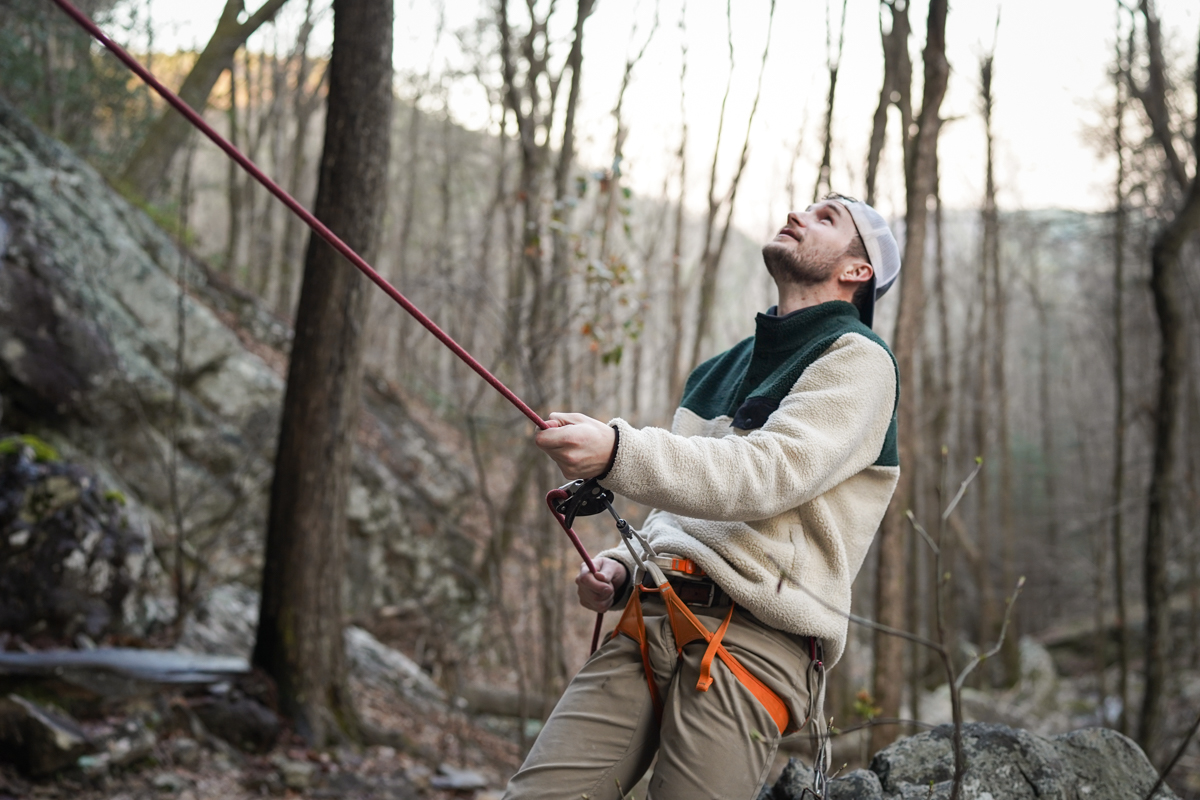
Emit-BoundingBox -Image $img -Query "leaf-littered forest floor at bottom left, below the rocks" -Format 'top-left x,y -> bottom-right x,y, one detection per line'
0,681 -> 520,800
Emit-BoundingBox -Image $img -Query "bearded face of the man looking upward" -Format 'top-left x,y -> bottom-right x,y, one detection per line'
762,200 -> 858,285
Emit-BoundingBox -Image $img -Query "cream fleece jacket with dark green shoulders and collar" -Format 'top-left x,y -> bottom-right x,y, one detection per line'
601,301 -> 900,666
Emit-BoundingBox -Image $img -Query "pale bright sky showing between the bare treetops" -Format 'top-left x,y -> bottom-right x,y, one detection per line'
136,0 -> 1200,235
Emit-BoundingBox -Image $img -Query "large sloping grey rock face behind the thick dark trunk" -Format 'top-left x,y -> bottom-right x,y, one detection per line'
0,95 -> 480,643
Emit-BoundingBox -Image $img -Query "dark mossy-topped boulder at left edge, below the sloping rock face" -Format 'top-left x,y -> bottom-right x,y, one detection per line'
0,438 -> 167,642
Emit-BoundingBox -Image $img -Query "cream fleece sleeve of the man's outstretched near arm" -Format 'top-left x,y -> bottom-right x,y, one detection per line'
602,333 -> 896,522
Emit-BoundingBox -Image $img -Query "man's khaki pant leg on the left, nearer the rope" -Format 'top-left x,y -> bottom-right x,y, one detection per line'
504,616 -> 676,800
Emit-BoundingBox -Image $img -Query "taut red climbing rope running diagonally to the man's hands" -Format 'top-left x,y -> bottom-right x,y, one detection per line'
54,0 -> 604,651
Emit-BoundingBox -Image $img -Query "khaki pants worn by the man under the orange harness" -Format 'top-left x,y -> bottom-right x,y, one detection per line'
504,595 -> 809,800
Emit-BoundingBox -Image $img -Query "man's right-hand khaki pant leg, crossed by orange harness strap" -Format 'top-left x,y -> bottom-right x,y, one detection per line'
648,607 -> 809,800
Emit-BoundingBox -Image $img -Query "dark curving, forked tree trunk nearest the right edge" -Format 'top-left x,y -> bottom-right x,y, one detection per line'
1129,0 -> 1200,752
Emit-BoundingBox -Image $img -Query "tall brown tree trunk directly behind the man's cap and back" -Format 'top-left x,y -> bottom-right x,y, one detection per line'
871,0 -> 949,751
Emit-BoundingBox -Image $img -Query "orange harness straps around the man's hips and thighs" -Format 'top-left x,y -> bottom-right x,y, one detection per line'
613,584 -> 791,733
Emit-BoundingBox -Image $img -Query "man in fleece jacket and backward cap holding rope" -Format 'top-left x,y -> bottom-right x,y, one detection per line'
506,196 -> 900,800
